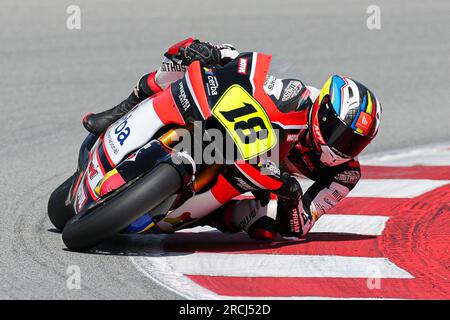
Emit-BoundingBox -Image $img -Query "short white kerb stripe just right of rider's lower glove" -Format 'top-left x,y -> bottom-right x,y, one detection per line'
310,214 -> 389,236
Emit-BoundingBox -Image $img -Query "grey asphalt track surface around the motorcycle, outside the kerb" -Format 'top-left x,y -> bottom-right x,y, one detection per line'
0,0 -> 450,299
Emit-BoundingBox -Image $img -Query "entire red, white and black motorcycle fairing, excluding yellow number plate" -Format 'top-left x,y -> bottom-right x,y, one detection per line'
71,52 -> 312,218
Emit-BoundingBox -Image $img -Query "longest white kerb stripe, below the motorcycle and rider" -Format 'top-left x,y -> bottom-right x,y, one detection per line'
144,252 -> 413,279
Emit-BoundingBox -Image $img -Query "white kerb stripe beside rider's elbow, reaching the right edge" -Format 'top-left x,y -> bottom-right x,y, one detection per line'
300,179 -> 450,198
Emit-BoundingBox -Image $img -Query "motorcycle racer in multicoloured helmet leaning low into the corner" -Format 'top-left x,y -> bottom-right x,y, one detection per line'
83,38 -> 381,240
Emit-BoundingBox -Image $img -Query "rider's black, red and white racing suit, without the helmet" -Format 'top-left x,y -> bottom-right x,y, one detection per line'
83,38 -> 360,240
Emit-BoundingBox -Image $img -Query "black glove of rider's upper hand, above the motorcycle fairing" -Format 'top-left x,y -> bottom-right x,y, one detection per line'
179,40 -> 221,66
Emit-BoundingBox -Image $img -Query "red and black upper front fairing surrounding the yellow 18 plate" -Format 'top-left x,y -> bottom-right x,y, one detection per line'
171,52 -> 307,190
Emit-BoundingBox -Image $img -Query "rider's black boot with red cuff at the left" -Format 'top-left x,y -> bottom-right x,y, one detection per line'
83,72 -> 161,136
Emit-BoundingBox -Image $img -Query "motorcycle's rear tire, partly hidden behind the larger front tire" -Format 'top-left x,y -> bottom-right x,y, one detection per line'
47,175 -> 75,230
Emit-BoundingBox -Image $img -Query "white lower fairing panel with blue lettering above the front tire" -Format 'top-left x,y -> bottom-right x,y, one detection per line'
71,94 -> 185,213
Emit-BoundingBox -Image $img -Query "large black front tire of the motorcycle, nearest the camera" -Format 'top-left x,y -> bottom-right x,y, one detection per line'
62,163 -> 182,251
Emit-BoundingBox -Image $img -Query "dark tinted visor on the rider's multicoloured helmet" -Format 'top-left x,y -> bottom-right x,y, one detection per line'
318,99 -> 371,158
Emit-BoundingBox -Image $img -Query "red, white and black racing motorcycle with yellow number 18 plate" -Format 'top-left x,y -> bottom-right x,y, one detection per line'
48,52 -> 307,251
